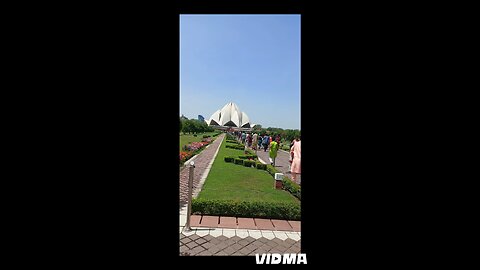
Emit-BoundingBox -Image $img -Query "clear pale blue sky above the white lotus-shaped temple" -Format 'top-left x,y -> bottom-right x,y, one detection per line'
180,14 -> 301,129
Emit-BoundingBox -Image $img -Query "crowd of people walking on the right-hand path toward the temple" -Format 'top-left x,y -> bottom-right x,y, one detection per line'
231,131 -> 302,184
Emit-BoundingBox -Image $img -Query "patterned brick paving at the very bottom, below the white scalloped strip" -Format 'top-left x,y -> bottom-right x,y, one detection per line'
180,233 -> 301,256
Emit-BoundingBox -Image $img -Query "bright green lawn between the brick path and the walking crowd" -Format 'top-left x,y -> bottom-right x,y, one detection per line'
198,136 -> 300,204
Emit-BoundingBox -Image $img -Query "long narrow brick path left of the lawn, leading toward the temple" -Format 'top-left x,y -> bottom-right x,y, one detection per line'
180,133 -> 225,206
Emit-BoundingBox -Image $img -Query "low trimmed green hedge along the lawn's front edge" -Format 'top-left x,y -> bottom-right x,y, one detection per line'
192,199 -> 301,220
